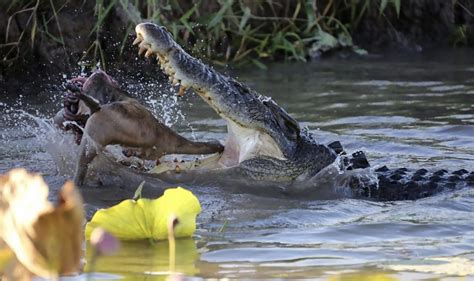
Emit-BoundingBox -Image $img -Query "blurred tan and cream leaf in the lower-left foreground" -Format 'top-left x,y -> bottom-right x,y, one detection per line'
0,169 -> 84,277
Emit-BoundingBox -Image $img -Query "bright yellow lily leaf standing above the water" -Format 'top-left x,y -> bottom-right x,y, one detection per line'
86,187 -> 201,240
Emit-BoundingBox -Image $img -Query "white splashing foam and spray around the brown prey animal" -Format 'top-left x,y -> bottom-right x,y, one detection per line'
0,71 -> 194,185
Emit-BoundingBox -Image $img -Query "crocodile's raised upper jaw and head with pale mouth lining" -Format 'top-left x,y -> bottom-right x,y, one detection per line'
134,23 -> 318,173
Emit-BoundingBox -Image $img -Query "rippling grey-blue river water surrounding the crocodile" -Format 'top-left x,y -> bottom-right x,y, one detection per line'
0,51 -> 474,280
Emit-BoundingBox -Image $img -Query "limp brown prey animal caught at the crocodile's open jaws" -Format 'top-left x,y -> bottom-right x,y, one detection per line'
54,71 -> 224,185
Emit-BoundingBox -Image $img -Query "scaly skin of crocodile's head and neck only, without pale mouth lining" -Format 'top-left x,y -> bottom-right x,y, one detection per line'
136,23 -> 337,181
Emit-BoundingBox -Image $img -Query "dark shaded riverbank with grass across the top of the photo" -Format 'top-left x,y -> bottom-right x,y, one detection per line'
0,0 -> 474,76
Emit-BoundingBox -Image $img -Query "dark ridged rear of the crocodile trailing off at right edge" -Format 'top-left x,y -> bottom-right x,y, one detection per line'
361,166 -> 474,201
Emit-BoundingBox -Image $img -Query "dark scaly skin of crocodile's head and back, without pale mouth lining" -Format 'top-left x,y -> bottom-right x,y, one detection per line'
129,23 -> 474,200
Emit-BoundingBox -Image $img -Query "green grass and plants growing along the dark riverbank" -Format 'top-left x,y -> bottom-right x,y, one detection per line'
0,0 -> 467,68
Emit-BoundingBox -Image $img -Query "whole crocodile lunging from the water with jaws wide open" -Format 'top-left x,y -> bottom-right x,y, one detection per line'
60,23 -> 474,200
